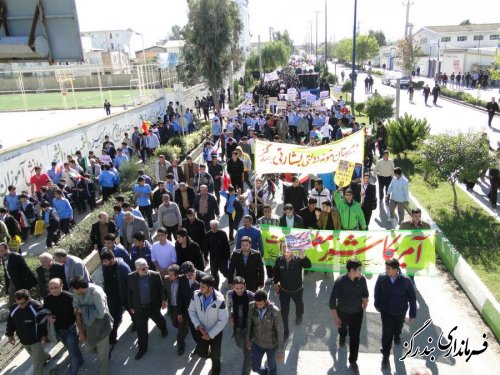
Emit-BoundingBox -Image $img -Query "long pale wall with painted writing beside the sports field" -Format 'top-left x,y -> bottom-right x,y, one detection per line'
0,98 -> 166,199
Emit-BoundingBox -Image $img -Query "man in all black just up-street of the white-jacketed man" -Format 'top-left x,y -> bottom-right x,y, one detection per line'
205,220 -> 231,290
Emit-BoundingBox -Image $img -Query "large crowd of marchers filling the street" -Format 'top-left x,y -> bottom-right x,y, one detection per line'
0,89 -> 429,375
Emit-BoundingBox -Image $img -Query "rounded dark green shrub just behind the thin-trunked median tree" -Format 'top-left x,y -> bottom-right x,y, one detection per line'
385,114 -> 430,157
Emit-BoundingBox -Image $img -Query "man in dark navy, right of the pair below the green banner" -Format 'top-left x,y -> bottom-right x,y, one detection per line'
375,258 -> 417,368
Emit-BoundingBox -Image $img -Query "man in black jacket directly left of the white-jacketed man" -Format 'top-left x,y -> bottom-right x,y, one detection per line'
177,262 -> 206,354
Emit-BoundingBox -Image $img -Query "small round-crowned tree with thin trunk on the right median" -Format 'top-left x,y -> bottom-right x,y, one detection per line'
419,131 -> 494,216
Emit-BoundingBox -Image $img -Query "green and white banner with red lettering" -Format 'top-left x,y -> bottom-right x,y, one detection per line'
260,225 -> 436,275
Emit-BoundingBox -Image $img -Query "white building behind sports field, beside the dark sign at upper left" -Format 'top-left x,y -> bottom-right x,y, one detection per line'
80,29 -> 135,59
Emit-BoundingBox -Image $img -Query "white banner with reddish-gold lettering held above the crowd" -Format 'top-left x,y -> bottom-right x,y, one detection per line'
255,129 -> 365,174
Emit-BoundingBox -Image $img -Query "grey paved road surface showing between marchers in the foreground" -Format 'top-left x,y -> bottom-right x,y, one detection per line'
3,184 -> 500,375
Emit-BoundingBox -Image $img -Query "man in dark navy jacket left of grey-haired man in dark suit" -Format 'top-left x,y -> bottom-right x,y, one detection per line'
101,249 -> 131,345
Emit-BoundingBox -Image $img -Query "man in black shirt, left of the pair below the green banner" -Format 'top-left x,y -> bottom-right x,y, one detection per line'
330,259 -> 368,373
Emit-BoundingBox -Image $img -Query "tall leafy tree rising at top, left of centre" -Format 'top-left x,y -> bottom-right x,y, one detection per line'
183,0 -> 243,102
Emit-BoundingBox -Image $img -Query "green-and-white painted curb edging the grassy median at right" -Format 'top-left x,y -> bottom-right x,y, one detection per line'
410,194 -> 500,341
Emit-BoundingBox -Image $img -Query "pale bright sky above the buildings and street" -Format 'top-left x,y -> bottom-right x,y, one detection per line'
76,0 -> 500,50
